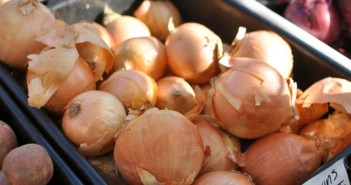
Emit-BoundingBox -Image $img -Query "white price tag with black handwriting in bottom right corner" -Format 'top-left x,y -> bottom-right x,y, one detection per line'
303,158 -> 350,185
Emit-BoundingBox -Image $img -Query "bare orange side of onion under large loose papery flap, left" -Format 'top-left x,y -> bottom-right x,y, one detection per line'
45,58 -> 96,114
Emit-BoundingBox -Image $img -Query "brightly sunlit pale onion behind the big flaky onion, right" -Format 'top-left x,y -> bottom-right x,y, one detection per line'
231,30 -> 294,79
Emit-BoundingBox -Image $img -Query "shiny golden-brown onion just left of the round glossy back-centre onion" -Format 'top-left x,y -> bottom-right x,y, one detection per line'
113,36 -> 167,80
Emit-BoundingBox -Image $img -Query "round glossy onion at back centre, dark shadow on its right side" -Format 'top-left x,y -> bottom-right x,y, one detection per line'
165,22 -> 223,84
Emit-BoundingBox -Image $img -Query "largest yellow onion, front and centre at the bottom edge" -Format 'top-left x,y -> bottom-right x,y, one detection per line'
114,108 -> 204,185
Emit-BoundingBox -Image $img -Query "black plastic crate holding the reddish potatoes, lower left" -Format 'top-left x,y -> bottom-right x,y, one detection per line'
0,83 -> 84,185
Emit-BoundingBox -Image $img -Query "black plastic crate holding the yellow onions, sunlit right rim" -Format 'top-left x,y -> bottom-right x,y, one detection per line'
0,0 -> 351,184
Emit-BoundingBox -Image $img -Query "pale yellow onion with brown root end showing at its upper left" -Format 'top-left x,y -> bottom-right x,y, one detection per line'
62,90 -> 126,157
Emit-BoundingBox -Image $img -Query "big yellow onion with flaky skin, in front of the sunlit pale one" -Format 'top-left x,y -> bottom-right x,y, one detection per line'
212,58 -> 292,139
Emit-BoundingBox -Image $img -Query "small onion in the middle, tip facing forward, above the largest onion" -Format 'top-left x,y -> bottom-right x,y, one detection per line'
156,76 -> 197,114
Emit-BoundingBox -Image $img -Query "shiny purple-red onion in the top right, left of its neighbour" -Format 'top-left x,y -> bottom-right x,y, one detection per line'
284,0 -> 341,44
